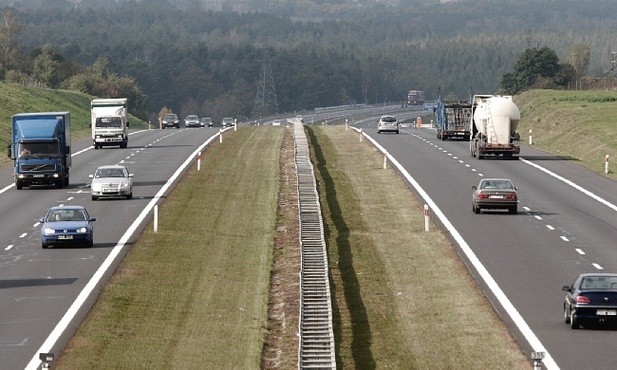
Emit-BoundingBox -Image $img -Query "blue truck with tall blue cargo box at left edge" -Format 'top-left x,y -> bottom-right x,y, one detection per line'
7,112 -> 71,190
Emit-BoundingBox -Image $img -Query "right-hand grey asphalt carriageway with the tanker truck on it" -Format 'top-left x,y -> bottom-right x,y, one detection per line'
348,120 -> 617,369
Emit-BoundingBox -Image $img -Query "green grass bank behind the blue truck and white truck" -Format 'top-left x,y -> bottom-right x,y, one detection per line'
0,82 -> 147,165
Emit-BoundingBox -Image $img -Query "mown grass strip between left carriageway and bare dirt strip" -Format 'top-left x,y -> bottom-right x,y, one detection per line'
57,128 -> 283,369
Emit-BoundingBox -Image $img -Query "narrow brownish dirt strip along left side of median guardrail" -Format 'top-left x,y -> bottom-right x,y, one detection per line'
261,129 -> 300,369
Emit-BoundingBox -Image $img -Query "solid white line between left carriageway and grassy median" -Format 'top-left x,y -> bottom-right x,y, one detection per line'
25,132 -> 225,370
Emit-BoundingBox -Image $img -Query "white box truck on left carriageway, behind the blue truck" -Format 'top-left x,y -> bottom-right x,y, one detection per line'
90,98 -> 129,149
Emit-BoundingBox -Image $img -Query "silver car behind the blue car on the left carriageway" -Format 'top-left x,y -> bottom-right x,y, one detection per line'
90,165 -> 133,200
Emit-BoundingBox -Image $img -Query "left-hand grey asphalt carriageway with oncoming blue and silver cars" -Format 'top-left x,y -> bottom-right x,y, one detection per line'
0,128 -> 219,369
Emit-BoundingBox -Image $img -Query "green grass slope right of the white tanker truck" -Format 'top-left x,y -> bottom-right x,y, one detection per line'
514,90 -> 617,179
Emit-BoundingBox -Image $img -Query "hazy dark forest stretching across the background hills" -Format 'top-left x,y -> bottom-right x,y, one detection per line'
0,0 -> 617,122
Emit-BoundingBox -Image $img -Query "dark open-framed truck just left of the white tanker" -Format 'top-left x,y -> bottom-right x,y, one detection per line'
435,97 -> 471,141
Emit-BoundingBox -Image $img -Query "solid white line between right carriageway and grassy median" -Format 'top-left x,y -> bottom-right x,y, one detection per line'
352,127 -> 559,369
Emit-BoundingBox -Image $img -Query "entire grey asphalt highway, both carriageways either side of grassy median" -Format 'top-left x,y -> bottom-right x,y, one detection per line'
0,106 -> 617,369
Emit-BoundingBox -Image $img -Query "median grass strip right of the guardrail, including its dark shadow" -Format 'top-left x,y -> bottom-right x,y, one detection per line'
306,126 -> 530,369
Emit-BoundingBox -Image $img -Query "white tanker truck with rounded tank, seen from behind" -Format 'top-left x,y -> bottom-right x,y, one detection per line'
469,95 -> 521,159
